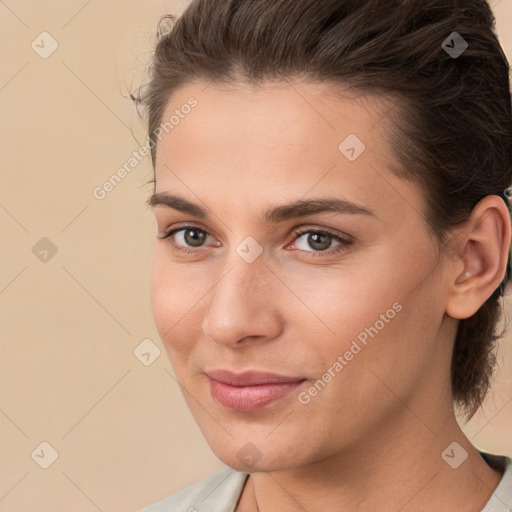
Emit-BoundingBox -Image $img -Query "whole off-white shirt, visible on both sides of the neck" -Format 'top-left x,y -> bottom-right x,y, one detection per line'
140,456 -> 512,512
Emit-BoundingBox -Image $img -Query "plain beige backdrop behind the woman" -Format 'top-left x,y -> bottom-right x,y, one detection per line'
0,0 -> 512,512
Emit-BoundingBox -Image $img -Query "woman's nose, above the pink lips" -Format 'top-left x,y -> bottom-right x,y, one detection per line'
202,256 -> 283,347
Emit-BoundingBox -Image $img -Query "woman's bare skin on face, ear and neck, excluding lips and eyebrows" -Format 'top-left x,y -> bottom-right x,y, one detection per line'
151,81 -> 510,512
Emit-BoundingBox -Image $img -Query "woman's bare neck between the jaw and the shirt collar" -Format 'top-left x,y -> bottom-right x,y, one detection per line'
237,404 -> 502,512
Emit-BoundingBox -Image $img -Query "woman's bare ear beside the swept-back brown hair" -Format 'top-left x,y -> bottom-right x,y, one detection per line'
446,195 -> 511,320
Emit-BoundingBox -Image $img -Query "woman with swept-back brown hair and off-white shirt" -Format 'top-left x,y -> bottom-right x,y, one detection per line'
138,0 -> 512,512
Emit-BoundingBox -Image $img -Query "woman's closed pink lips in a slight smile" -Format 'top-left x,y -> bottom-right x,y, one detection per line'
206,370 -> 306,412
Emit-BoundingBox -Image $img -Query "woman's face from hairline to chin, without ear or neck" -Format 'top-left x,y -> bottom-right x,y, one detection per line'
151,82 -> 456,471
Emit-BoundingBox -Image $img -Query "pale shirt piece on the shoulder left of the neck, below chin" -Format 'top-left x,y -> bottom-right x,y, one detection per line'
140,468 -> 248,512
